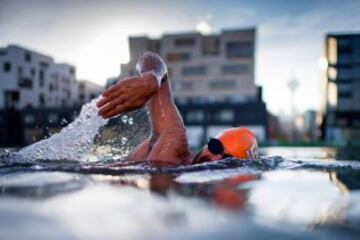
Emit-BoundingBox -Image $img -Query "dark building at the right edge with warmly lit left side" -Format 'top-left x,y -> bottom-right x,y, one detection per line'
323,33 -> 360,144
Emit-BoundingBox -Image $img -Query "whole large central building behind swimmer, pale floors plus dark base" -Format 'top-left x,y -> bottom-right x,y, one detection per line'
119,28 -> 267,145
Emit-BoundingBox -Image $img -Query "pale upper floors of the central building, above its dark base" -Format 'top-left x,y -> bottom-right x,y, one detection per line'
121,28 -> 258,102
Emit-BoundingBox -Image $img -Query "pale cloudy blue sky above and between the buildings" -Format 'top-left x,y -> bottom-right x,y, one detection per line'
0,0 -> 360,115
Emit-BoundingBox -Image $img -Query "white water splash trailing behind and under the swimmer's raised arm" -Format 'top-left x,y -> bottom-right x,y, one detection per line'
15,97 -> 148,162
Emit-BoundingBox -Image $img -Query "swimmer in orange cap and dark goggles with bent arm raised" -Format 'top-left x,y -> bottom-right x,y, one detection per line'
97,52 -> 258,167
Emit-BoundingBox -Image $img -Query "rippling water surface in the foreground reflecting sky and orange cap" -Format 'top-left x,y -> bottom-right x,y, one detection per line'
0,148 -> 360,239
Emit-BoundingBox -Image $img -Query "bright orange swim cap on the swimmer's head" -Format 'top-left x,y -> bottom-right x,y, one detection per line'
216,127 -> 259,160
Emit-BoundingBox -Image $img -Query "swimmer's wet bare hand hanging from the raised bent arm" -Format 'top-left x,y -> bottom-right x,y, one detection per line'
96,73 -> 160,118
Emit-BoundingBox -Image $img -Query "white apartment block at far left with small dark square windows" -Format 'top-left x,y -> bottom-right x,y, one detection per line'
0,45 -> 78,109
